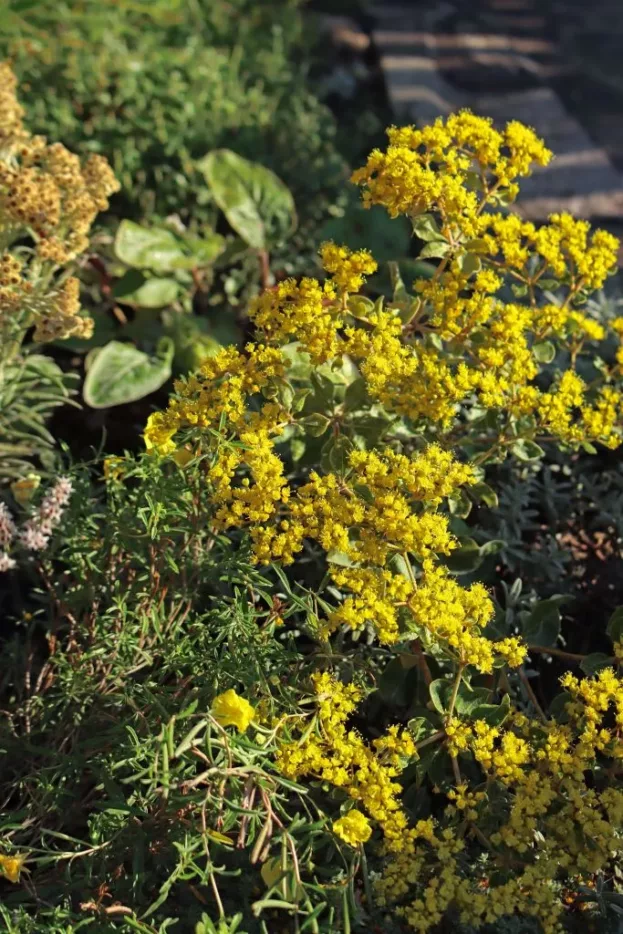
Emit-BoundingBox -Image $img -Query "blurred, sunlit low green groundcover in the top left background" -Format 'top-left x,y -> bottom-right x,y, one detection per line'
0,0 -> 346,268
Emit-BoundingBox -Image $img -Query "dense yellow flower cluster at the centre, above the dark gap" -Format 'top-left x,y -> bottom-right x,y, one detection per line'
251,445 -> 496,644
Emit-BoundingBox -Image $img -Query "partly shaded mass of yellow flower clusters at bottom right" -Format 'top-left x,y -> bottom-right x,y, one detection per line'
276,673 -> 604,934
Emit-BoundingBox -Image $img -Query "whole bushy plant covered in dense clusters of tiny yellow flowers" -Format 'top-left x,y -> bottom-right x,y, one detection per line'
140,112 -> 623,934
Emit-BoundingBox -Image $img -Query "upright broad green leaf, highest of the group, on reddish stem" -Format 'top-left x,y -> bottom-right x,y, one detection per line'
197,149 -> 296,250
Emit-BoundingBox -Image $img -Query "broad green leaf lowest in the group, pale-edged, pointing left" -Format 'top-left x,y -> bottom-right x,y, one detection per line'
83,337 -> 174,409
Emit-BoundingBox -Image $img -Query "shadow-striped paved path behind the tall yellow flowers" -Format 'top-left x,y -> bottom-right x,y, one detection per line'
371,0 -> 623,224
